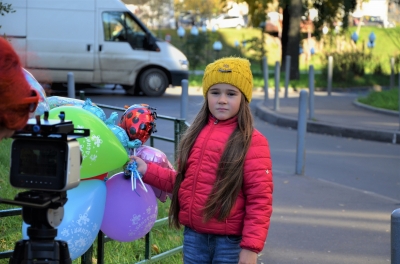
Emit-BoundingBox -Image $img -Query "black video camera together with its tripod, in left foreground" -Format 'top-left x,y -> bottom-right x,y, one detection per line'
0,112 -> 90,264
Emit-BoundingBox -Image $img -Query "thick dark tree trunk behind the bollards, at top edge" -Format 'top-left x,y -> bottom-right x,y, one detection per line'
281,0 -> 302,80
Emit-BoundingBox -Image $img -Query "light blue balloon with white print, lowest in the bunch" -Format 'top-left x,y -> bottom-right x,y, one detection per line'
22,180 -> 106,260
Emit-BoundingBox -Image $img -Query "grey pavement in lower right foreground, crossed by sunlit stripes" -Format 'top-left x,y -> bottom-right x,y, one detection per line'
257,173 -> 399,264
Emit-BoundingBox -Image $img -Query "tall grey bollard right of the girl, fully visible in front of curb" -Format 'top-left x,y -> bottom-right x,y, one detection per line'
296,90 -> 308,175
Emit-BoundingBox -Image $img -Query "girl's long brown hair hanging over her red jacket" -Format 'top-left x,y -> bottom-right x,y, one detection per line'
169,94 -> 253,228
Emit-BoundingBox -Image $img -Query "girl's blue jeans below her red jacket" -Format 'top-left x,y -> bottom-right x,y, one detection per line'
183,226 -> 242,264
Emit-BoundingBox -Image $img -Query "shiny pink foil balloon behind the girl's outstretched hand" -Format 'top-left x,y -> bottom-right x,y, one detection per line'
136,145 -> 174,203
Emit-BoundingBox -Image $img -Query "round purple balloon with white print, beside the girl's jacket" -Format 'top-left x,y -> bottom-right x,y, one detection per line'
100,172 -> 158,242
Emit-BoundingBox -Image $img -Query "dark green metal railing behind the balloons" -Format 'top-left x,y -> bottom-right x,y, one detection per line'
0,102 -> 189,264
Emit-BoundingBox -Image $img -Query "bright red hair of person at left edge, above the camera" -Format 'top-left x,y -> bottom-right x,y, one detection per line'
0,38 -> 39,141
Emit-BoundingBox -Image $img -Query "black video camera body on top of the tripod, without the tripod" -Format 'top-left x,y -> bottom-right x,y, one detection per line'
10,112 -> 89,191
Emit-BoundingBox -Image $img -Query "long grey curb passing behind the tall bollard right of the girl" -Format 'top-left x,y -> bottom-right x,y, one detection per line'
255,103 -> 400,144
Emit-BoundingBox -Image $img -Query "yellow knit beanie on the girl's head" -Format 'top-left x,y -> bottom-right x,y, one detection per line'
203,57 -> 253,103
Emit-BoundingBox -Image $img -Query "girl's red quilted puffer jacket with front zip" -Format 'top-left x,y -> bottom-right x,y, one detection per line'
143,114 -> 273,253
